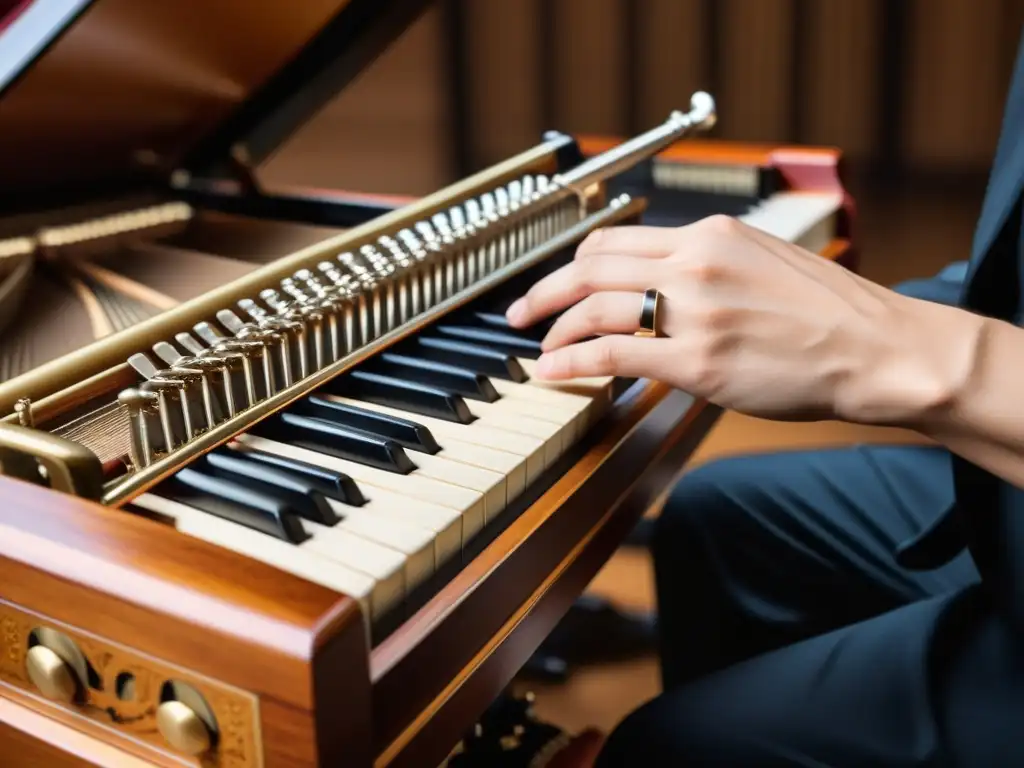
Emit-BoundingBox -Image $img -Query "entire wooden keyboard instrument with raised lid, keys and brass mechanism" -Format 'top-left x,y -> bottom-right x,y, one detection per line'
0,0 -> 850,767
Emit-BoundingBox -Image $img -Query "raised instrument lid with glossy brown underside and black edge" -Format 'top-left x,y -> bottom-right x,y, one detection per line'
0,0 -> 429,215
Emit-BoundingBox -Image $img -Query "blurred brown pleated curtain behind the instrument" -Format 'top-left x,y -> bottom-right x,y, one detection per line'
264,0 -> 1024,194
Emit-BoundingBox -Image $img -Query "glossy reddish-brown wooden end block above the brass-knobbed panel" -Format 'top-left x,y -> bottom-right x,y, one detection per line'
0,478 -> 370,766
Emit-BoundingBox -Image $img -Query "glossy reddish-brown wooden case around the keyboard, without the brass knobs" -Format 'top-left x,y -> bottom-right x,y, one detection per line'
0,139 -> 855,768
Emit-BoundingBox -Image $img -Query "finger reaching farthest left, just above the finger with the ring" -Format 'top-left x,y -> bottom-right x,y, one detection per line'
506,254 -> 665,328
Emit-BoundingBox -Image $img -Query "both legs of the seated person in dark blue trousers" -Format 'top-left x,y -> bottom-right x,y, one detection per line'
598,446 -> 991,768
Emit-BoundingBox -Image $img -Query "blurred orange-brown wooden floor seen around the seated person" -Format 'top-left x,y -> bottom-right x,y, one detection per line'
516,180 -> 981,732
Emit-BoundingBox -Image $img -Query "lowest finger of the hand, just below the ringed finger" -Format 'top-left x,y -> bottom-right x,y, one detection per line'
537,336 -> 673,381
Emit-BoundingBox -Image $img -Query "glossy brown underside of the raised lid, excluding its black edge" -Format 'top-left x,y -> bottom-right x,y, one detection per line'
0,0 -> 348,194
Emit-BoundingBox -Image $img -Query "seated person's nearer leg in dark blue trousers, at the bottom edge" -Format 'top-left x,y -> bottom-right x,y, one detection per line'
596,587 -> 1011,768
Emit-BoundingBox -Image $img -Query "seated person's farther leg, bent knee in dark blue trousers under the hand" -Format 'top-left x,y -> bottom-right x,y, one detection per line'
651,445 -> 977,688
